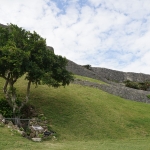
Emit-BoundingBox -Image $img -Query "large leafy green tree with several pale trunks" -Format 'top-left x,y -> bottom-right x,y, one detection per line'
0,24 -> 73,124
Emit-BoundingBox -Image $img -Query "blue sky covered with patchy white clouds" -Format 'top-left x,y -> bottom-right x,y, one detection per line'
0,0 -> 150,74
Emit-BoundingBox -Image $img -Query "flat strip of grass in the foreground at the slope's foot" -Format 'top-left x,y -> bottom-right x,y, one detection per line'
0,127 -> 150,150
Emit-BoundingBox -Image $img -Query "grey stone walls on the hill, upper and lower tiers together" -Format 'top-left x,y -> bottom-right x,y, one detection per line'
67,60 -> 150,103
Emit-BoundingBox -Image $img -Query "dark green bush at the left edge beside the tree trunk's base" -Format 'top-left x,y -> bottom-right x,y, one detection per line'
0,99 -> 13,118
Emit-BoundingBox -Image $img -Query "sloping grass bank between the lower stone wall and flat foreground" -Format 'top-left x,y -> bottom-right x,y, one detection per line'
0,76 -> 150,140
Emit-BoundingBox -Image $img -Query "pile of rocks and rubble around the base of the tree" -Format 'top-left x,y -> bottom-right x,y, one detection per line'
0,114 -> 56,142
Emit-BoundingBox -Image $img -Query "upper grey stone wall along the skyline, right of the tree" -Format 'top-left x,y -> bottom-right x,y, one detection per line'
66,60 -> 150,82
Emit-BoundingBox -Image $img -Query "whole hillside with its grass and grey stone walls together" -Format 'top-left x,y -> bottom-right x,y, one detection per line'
0,22 -> 150,150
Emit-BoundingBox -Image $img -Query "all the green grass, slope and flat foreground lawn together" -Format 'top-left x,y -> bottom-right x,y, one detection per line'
0,76 -> 150,149
